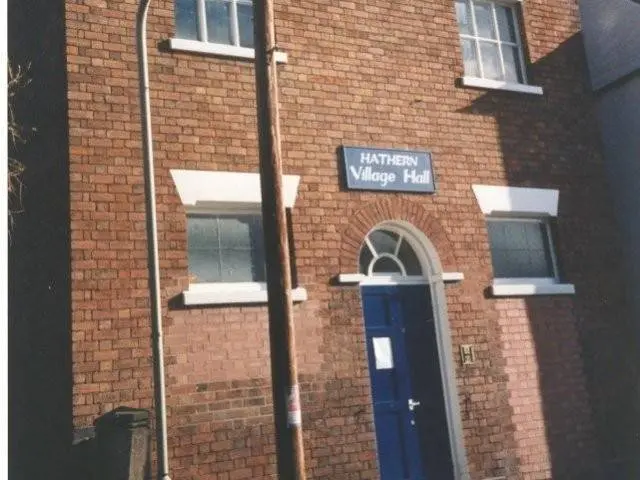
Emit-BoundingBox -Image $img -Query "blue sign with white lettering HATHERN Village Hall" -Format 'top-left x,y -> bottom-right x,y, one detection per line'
342,146 -> 436,193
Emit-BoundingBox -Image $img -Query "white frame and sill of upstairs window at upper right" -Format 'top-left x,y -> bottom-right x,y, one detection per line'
458,0 -> 543,95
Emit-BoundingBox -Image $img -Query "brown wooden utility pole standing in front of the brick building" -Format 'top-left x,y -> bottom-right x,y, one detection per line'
253,0 -> 306,480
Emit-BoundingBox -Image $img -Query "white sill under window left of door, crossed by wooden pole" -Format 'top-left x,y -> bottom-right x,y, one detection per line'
182,283 -> 307,306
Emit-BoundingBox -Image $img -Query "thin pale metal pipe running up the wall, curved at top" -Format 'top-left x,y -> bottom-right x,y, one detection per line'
136,0 -> 171,480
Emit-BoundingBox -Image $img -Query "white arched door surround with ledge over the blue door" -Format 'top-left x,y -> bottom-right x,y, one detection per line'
352,221 -> 470,480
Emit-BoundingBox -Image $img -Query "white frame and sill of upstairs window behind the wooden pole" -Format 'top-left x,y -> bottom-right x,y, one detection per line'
169,0 -> 287,63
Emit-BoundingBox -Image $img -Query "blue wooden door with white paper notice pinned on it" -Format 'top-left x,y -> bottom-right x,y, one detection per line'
362,285 -> 453,480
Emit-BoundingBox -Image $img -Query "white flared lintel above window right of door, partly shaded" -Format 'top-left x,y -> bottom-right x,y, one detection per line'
472,185 -> 559,217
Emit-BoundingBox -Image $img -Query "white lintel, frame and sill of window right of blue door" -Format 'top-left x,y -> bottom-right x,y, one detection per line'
472,185 -> 575,297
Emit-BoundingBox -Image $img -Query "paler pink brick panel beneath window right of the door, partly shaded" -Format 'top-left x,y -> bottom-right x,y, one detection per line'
497,298 -> 598,478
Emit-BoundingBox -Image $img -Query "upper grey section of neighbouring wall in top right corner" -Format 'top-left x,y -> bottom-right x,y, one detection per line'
580,0 -> 640,90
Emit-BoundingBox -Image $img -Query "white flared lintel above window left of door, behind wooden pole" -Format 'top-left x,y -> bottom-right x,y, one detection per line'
171,169 -> 300,208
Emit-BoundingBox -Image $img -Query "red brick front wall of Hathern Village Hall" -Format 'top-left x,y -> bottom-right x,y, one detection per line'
10,0 -> 632,480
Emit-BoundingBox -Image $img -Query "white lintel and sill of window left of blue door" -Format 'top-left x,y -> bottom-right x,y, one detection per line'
170,169 -> 307,306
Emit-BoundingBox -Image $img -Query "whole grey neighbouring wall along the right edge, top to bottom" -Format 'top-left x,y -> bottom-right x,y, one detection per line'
580,4 -> 640,472
